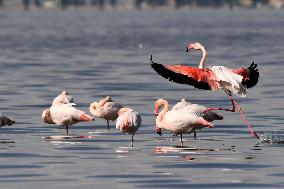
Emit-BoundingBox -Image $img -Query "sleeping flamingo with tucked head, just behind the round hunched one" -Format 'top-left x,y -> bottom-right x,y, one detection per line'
89,96 -> 123,130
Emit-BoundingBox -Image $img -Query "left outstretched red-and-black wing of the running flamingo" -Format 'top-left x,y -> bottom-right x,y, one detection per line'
150,56 -> 215,90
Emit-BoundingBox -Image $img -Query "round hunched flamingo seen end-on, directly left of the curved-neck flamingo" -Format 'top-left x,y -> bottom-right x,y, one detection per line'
116,108 -> 142,147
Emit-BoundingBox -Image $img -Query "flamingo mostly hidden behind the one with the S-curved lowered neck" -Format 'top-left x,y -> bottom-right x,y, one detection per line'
172,98 -> 224,139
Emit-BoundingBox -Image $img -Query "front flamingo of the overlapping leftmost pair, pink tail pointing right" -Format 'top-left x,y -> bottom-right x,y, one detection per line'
42,104 -> 94,135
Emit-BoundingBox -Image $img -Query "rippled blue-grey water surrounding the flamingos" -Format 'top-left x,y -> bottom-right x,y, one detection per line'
0,9 -> 284,189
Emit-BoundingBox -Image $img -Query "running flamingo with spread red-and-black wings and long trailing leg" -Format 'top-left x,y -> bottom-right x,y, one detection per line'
150,43 -> 259,139
